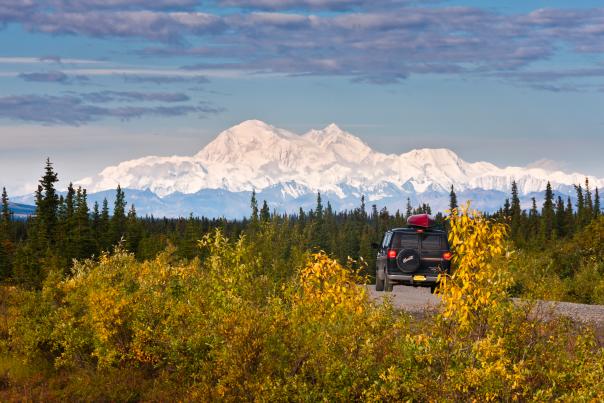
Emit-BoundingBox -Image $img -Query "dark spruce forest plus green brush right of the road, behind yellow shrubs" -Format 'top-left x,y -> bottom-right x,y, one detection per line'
0,161 -> 604,304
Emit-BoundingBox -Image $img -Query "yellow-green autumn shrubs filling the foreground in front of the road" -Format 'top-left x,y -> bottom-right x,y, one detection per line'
0,223 -> 604,402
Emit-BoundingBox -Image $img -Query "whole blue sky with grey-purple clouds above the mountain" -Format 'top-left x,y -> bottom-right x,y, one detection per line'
0,0 -> 604,194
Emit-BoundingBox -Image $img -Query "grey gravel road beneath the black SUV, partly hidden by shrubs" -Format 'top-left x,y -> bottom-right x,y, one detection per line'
367,285 -> 604,328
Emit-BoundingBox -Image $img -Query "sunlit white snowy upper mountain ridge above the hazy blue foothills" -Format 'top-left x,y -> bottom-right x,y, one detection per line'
76,120 -> 604,200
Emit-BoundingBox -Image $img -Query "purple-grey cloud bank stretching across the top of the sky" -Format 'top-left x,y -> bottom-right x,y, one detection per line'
0,0 -> 604,88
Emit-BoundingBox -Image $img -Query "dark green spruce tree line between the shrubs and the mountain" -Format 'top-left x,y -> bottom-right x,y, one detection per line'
0,160 -> 601,288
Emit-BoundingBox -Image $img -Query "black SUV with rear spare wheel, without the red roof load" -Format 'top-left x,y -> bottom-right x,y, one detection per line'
374,220 -> 452,292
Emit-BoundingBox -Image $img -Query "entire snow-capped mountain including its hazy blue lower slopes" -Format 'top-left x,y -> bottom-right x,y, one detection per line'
77,120 -> 604,216
